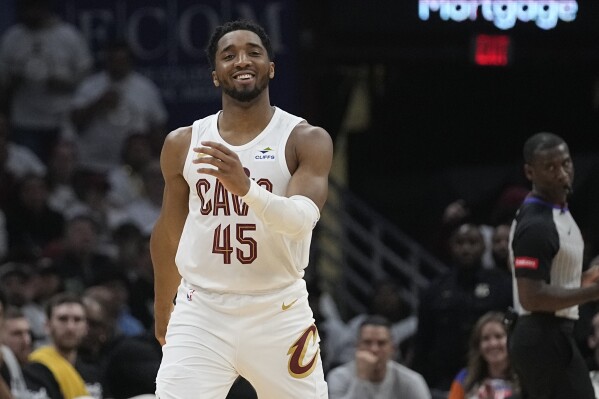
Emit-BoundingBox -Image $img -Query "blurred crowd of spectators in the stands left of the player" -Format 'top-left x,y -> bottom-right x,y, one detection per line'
0,0 -> 168,399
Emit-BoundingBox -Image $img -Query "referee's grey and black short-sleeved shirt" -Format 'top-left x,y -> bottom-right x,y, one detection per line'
509,197 -> 584,319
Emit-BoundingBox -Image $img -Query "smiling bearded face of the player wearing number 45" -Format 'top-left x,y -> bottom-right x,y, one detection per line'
212,30 -> 274,102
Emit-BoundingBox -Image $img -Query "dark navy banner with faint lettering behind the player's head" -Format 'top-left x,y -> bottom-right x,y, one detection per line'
60,0 -> 299,128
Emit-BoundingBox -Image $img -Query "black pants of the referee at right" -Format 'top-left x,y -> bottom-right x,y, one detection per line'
509,314 -> 595,399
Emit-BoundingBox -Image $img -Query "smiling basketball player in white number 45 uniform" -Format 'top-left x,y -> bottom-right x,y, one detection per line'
151,21 -> 333,399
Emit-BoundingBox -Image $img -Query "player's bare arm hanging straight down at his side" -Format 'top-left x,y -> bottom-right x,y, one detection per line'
150,127 -> 191,345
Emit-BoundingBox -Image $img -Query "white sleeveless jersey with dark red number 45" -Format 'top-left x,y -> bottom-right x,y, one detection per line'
175,108 -> 311,293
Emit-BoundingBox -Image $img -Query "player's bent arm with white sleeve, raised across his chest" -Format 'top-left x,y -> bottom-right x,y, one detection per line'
193,122 -> 333,239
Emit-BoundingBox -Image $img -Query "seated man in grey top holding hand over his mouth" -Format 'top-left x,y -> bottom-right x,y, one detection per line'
327,316 -> 431,399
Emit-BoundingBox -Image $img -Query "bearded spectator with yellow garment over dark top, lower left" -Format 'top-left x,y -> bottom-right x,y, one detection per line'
24,293 -> 103,399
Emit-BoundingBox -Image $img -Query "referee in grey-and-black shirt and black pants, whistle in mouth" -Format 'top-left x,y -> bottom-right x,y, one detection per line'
509,133 -> 599,399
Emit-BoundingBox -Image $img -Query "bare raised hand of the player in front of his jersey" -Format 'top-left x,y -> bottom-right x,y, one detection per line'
193,141 -> 250,197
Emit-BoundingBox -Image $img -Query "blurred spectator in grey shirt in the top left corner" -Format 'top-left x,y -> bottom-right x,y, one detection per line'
0,0 -> 93,161
